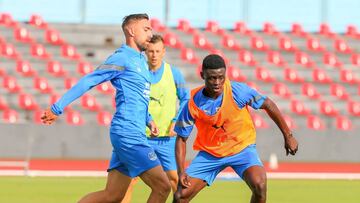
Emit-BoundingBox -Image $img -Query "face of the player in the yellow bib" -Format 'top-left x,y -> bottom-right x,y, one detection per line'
145,41 -> 165,67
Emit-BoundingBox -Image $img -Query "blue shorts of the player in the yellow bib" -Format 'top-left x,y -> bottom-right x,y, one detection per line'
148,136 -> 177,171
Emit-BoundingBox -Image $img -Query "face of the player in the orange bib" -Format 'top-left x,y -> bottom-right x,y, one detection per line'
201,68 -> 226,97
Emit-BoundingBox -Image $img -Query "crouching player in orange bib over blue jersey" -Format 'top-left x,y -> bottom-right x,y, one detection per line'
174,55 -> 298,203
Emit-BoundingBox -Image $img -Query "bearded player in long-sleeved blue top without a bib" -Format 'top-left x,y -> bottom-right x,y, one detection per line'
42,14 -> 171,203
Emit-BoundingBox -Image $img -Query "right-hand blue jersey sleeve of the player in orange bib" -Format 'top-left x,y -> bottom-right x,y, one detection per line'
231,82 -> 266,109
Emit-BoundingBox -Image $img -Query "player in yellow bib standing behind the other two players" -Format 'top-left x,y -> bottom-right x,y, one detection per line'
122,35 -> 190,203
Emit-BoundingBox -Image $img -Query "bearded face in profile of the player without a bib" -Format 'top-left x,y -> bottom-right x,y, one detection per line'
134,19 -> 152,51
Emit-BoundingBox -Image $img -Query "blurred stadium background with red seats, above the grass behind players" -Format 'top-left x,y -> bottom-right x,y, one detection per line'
0,0 -> 360,178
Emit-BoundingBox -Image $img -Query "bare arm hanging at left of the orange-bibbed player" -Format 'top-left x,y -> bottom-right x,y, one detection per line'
175,136 -> 190,187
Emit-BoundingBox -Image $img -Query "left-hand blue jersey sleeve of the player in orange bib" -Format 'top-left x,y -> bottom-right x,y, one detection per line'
174,102 -> 195,137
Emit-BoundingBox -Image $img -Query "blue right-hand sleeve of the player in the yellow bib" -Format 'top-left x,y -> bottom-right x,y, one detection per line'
171,67 -> 190,122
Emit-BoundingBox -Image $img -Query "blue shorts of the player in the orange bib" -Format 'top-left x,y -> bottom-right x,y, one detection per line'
186,144 -> 263,186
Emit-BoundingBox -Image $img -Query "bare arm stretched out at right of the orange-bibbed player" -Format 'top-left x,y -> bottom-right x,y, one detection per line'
260,98 -> 298,155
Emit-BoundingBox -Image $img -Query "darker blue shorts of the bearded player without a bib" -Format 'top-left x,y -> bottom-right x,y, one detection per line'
108,144 -> 160,178
